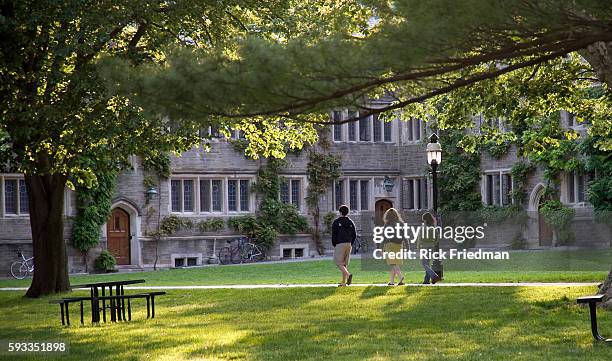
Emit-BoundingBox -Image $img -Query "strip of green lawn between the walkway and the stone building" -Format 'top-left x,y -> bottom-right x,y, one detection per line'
0,250 -> 612,287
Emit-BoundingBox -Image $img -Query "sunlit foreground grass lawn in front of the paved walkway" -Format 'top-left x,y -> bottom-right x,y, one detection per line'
0,287 -> 612,361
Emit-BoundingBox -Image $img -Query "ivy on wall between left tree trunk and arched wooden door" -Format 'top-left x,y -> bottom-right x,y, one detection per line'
72,172 -> 117,271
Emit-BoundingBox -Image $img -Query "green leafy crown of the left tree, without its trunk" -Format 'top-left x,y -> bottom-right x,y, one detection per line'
0,0 -> 350,186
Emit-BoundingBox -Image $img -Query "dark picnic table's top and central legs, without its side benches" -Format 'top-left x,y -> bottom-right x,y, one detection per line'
70,280 -> 145,322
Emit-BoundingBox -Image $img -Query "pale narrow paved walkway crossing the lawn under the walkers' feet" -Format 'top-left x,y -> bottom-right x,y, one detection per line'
0,282 -> 599,291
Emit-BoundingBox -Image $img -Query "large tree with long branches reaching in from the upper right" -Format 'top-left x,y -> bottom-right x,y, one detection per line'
107,0 -> 612,290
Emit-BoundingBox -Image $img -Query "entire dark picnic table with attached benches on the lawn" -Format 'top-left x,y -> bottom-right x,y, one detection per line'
49,280 -> 166,325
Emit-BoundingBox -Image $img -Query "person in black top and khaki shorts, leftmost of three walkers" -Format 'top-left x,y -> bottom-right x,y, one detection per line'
332,206 -> 357,287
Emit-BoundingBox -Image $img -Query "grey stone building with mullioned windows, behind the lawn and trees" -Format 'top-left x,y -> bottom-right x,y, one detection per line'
0,109 -> 612,275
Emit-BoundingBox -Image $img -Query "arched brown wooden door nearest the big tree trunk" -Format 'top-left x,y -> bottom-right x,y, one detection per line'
106,208 -> 130,265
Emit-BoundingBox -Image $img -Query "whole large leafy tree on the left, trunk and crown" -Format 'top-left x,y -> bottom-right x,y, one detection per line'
0,0 -> 365,297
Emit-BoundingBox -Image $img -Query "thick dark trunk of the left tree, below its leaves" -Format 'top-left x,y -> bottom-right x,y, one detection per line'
25,174 -> 70,297
